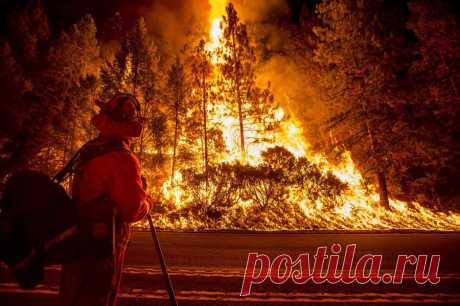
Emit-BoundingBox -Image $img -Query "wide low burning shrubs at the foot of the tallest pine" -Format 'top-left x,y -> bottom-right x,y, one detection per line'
159,147 -> 346,229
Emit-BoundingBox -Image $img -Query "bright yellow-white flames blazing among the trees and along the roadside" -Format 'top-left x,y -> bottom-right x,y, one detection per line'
154,0 -> 460,230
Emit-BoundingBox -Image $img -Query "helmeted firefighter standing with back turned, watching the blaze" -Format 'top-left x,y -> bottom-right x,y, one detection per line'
59,94 -> 151,306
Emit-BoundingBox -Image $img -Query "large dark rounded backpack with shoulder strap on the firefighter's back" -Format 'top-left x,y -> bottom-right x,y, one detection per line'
0,139 -> 129,289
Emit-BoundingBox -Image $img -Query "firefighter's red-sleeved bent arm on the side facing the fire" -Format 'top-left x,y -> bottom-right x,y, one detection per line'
109,152 -> 151,222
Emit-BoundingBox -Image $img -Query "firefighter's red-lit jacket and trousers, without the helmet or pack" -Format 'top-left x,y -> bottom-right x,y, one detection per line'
60,137 -> 150,306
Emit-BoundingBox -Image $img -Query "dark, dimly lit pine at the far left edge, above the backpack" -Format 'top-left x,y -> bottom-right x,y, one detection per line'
0,1 -> 51,177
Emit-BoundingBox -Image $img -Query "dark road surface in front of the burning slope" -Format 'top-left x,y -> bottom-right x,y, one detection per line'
0,232 -> 460,306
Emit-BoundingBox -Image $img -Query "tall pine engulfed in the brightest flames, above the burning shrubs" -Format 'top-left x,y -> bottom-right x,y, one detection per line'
217,3 -> 275,162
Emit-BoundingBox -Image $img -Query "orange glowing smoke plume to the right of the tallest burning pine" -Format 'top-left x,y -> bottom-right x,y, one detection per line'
229,0 -> 327,149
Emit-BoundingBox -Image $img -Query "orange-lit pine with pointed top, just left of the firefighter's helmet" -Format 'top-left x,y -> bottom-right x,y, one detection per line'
35,15 -> 99,167
